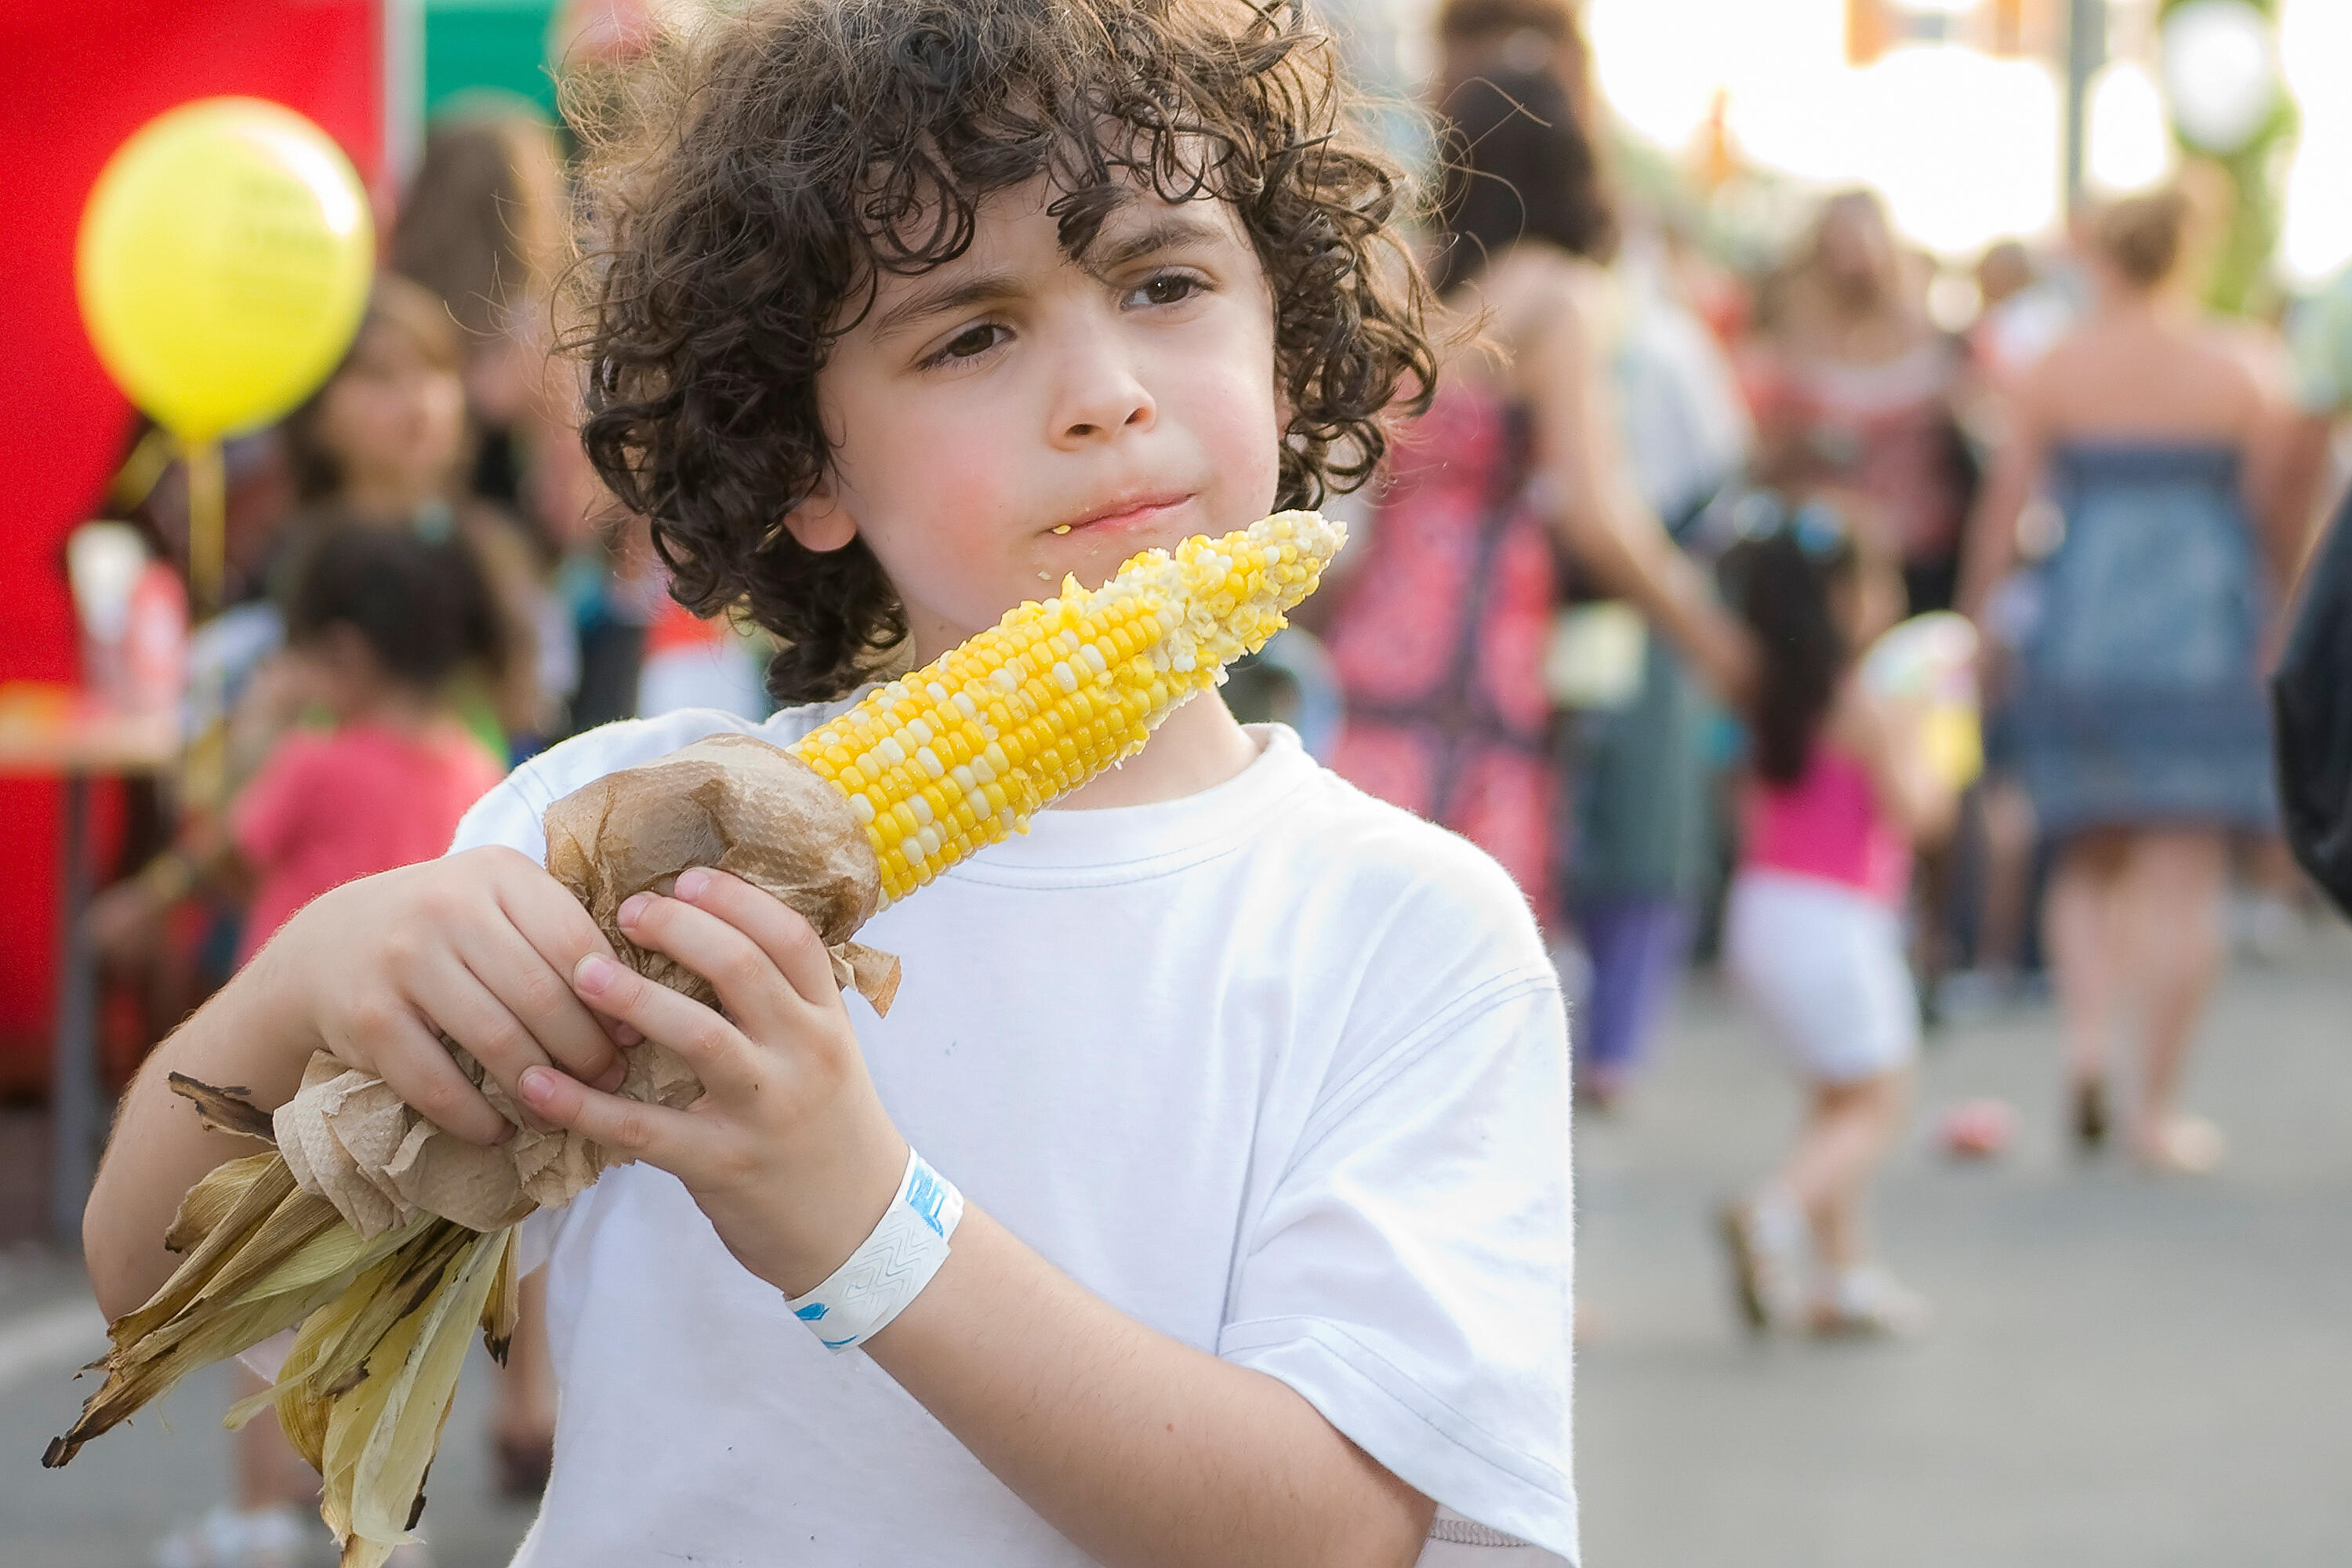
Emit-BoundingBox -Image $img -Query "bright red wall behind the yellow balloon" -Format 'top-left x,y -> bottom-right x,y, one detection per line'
0,0 -> 383,1100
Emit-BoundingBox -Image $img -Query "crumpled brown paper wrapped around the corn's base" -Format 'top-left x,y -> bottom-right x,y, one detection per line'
273,736 -> 898,1236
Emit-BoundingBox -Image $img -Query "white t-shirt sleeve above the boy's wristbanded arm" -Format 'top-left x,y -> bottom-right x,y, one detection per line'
1218,959 -> 1578,1563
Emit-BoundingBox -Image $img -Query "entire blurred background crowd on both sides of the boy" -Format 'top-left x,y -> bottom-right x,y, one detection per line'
68,0 -> 2352,1563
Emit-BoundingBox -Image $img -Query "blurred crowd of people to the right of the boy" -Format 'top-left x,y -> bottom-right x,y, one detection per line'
1289,0 -> 2352,1333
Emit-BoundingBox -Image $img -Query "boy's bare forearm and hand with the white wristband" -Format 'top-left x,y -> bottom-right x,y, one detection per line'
522,872 -> 1435,1568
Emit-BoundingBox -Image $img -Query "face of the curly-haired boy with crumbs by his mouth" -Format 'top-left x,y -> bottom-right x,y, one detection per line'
788,181 -> 1282,661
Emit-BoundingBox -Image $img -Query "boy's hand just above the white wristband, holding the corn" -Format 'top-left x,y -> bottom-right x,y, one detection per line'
520,869 -> 906,1295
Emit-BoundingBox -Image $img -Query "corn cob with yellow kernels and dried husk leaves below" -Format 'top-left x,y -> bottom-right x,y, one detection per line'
42,513 -> 1345,1568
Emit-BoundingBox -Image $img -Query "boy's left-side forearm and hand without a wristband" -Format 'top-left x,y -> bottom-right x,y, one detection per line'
82,848 -> 621,1319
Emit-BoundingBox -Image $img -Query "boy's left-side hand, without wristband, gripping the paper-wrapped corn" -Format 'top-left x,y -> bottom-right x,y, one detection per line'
273,848 -> 635,1142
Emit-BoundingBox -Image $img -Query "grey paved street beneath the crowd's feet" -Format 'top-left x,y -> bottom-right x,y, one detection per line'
0,933 -> 2352,1568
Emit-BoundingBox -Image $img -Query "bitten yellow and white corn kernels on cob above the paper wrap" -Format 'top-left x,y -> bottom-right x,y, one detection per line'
793,513 -> 1343,898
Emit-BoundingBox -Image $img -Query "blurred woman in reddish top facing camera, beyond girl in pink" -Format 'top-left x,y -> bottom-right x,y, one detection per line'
1743,191 -> 1973,616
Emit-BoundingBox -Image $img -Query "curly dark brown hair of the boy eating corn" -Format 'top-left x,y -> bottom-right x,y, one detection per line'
569,0 -> 1435,701
